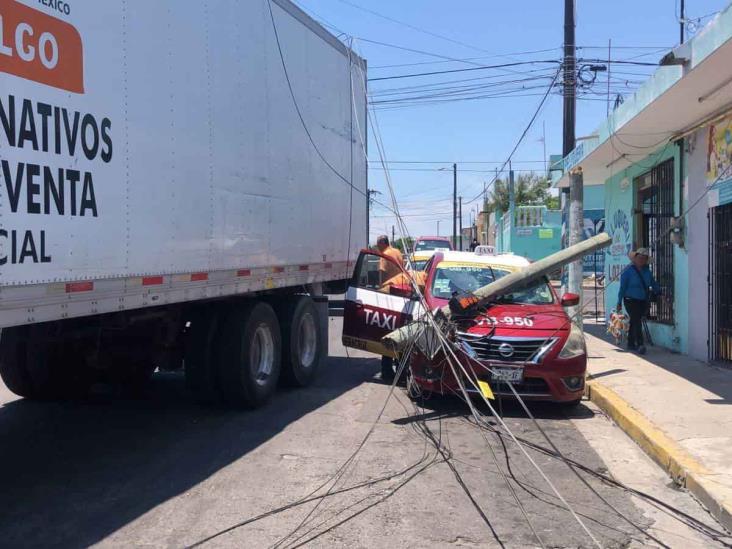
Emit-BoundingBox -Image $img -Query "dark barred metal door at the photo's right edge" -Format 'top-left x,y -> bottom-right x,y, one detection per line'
709,204 -> 732,364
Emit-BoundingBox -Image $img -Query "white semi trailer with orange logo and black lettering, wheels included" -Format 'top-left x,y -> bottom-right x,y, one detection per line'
0,0 -> 367,406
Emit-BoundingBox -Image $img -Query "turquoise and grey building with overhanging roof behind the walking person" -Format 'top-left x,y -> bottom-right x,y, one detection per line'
557,7 -> 732,365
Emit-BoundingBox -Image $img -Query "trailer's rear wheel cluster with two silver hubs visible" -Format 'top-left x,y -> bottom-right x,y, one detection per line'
185,296 -> 325,408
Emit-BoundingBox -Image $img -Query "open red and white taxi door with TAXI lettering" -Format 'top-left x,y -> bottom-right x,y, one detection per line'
342,250 -> 422,356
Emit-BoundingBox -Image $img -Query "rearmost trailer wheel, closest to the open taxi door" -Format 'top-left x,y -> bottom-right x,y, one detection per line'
278,295 -> 325,387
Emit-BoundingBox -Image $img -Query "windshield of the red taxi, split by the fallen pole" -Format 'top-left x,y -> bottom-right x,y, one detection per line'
432,261 -> 554,305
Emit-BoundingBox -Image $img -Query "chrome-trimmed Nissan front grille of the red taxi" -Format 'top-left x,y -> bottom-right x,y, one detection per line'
458,333 -> 557,364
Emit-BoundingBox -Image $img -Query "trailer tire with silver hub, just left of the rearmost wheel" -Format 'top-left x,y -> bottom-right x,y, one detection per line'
217,301 -> 282,408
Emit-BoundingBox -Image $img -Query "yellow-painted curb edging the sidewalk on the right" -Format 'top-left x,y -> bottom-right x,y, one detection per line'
585,380 -> 732,532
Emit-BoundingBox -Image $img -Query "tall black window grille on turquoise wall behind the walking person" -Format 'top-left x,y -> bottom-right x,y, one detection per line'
635,158 -> 674,324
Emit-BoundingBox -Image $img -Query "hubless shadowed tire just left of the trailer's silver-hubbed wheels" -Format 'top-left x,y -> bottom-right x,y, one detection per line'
183,305 -> 221,404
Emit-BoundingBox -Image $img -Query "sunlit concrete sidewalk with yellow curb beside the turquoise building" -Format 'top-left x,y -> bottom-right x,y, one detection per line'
585,322 -> 732,531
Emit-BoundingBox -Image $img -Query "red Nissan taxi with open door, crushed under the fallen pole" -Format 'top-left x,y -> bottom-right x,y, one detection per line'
343,251 -> 587,405
